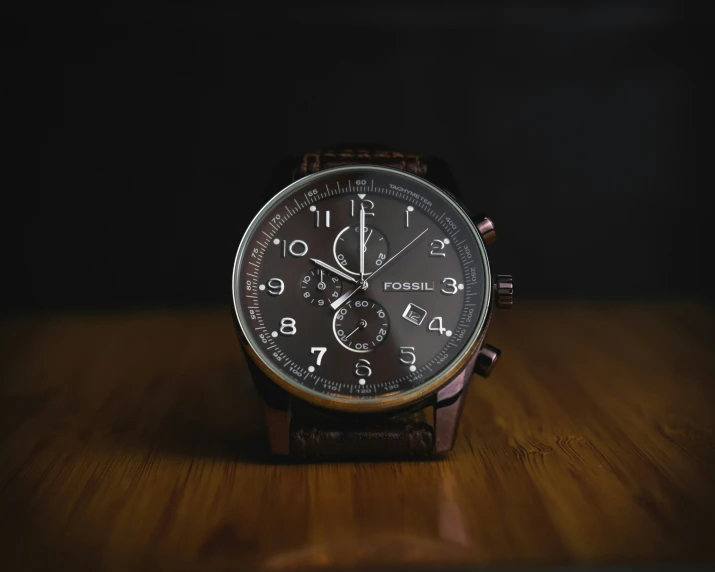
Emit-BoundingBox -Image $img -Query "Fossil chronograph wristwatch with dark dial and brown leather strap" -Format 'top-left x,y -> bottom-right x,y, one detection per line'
232,148 -> 513,459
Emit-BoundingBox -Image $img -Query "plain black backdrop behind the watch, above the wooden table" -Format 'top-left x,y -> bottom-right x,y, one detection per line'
1,1 -> 713,309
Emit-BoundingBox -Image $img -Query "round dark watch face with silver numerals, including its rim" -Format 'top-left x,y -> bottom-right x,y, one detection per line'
233,166 -> 491,410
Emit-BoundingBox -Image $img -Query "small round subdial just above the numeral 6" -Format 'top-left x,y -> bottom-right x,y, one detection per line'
333,300 -> 390,353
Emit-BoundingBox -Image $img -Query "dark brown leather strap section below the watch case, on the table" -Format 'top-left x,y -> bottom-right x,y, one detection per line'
290,420 -> 434,459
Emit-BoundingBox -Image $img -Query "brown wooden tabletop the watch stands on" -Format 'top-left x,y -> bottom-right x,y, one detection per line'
0,302 -> 715,571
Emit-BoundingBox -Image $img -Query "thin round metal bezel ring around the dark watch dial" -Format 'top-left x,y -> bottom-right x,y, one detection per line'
231,164 -> 492,413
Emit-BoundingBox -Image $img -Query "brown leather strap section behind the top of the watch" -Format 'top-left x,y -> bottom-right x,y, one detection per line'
296,149 -> 427,177
